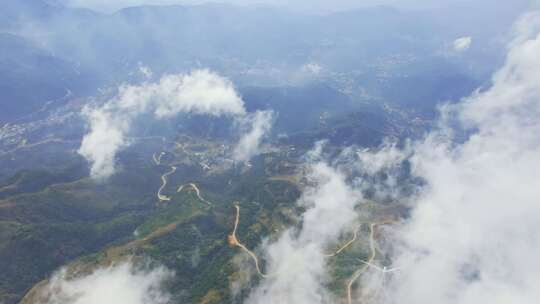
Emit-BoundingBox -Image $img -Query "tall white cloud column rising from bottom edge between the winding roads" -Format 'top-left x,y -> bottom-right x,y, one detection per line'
247,162 -> 360,304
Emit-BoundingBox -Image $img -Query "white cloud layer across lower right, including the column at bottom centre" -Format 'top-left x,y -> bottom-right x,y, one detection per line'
243,12 -> 540,304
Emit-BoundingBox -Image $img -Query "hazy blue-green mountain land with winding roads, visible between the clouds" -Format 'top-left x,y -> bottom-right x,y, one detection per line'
0,0 -> 532,304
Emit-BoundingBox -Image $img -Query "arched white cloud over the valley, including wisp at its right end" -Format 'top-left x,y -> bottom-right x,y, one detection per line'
79,70 -> 255,178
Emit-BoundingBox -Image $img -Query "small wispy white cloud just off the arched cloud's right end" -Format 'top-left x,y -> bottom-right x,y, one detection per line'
233,111 -> 273,162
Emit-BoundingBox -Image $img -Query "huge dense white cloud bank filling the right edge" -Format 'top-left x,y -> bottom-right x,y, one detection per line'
356,12 -> 540,304
